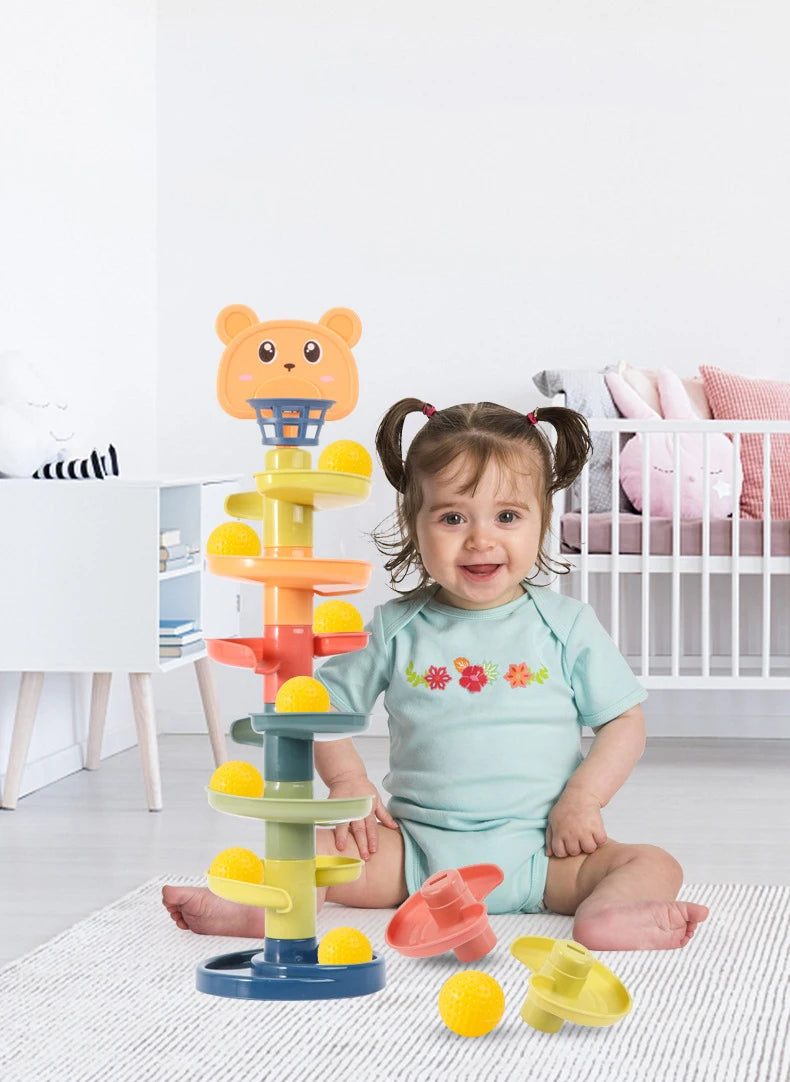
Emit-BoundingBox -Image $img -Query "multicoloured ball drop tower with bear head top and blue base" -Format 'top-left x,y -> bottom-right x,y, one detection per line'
196,305 -> 384,1000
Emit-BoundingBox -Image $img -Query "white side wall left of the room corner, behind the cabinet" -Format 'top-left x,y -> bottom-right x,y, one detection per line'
0,0 -> 157,790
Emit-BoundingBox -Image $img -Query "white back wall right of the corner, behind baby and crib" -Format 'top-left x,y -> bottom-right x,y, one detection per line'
158,0 -> 790,726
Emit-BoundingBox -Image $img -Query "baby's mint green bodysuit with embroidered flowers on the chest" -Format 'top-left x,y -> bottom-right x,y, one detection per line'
316,586 -> 646,913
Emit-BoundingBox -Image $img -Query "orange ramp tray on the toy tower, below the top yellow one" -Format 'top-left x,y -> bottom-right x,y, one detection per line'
206,555 -> 373,597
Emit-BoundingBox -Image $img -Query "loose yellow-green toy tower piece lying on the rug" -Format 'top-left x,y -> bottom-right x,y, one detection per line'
510,936 -> 631,1033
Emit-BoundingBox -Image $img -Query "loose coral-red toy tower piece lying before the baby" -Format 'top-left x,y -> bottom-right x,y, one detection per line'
384,865 -> 504,962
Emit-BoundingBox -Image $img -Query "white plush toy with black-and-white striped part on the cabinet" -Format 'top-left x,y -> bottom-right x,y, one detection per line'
0,353 -> 118,479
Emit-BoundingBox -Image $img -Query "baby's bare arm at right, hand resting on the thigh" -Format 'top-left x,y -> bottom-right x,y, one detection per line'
545,705 -> 645,857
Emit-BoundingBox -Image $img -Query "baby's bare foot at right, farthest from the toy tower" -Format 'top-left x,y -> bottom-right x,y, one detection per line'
572,901 -> 708,950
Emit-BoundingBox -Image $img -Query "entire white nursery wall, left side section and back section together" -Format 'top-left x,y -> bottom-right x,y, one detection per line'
0,0 -> 790,805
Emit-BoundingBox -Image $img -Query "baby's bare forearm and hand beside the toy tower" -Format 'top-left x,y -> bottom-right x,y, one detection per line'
314,737 -> 398,860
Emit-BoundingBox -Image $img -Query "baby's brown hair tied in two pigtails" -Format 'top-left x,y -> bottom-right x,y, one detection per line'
371,398 -> 592,595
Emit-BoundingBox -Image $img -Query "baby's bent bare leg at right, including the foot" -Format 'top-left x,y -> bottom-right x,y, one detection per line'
543,840 -> 708,950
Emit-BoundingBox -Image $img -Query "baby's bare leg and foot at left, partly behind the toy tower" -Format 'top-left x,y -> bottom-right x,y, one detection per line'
162,827 -> 407,939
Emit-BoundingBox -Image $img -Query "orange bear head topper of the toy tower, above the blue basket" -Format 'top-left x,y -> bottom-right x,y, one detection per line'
216,304 -> 361,421
